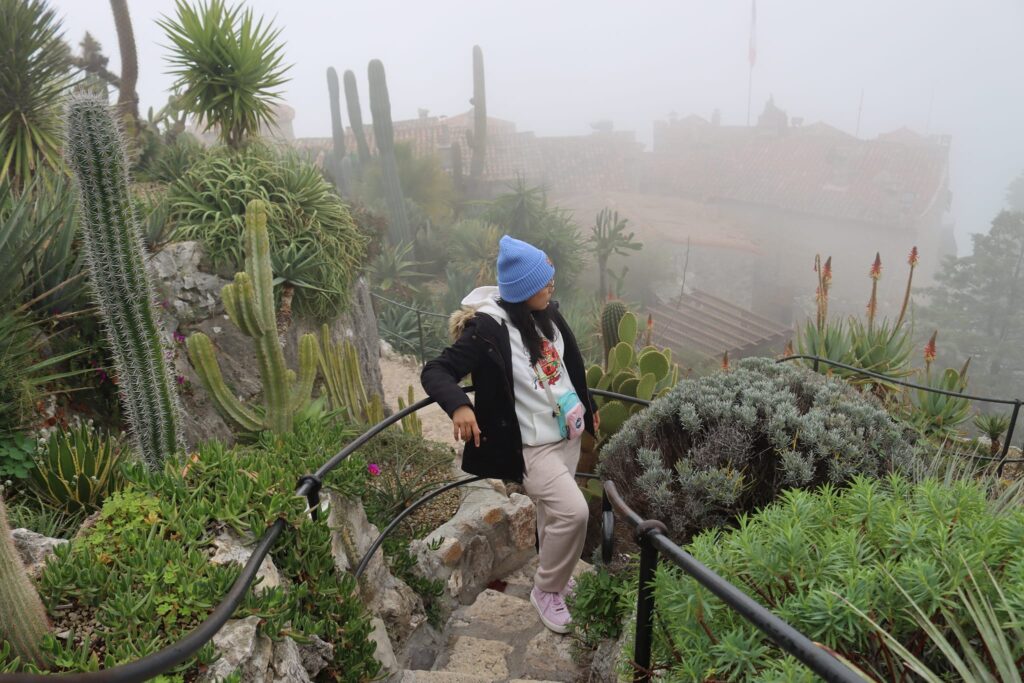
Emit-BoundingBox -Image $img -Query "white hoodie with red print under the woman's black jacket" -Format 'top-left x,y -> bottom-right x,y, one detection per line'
462,287 -> 574,445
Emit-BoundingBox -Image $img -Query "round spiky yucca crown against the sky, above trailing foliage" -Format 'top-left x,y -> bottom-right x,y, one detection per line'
157,0 -> 291,150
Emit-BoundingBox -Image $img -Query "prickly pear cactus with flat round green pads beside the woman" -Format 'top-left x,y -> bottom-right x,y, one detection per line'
587,311 -> 679,439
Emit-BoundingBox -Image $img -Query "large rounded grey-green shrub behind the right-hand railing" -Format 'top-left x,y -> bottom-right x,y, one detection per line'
598,358 -> 918,541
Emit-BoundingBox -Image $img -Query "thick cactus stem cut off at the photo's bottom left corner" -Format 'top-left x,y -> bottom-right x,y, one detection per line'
0,496 -> 50,668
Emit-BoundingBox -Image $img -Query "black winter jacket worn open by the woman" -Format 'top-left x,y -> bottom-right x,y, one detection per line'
420,302 -> 595,483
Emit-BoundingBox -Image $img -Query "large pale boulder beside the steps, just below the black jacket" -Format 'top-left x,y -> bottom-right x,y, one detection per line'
410,480 -> 537,609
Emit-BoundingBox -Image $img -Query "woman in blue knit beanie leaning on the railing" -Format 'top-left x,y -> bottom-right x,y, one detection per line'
421,236 -> 596,633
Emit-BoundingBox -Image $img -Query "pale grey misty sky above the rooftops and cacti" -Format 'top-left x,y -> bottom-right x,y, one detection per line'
50,0 -> 1024,257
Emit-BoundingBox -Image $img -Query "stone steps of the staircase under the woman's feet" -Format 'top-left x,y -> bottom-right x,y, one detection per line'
390,555 -> 591,683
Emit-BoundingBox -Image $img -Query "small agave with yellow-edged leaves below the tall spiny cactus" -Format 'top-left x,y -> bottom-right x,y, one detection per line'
29,424 -> 125,512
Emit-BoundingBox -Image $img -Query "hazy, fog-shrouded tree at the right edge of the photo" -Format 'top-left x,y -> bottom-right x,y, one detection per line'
922,211 -> 1024,397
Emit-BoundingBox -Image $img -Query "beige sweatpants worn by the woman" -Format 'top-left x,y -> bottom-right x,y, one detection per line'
522,438 -> 590,592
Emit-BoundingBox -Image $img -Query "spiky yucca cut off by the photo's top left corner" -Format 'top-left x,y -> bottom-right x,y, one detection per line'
0,0 -> 71,186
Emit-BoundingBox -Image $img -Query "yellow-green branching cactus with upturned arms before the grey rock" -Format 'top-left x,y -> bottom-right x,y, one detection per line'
186,200 -> 319,434
